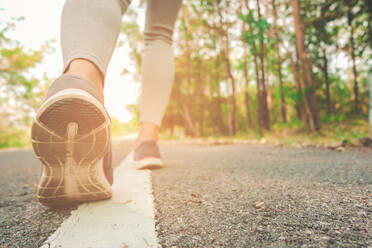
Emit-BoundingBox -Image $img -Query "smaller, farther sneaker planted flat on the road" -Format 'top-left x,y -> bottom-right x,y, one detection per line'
133,140 -> 164,170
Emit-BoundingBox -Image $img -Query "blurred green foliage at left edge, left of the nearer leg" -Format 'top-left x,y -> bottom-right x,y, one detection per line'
0,11 -> 48,148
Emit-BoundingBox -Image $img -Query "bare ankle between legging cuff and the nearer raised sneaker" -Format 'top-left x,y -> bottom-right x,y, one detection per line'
65,59 -> 103,95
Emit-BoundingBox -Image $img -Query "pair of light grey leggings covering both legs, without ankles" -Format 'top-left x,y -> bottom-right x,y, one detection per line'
61,0 -> 182,126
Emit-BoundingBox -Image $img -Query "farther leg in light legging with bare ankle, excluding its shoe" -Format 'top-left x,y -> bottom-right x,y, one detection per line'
137,0 -> 182,144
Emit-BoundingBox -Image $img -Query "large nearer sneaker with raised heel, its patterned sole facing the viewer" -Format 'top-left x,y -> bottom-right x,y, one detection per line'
31,74 -> 113,207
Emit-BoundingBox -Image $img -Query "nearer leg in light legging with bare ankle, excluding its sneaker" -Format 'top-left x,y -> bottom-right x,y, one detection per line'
61,0 -> 130,92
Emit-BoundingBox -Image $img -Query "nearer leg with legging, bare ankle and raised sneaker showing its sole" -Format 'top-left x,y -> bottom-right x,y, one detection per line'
31,0 -> 129,206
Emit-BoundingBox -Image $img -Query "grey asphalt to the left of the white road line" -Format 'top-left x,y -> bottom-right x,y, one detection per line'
0,141 -> 132,248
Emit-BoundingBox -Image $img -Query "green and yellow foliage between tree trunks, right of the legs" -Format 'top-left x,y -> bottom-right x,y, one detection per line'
150,0 -> 371,140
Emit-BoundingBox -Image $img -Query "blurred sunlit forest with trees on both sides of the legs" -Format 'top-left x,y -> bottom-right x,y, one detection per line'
0,0 -> 372,147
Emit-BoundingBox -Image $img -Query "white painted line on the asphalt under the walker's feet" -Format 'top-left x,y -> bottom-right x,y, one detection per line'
42,154 -> 160,248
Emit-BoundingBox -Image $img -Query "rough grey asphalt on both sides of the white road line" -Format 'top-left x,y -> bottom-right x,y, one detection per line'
0,141 -> 372,248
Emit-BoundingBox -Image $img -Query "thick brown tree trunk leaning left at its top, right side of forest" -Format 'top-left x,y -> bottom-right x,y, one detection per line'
291,0 -> 321,130
